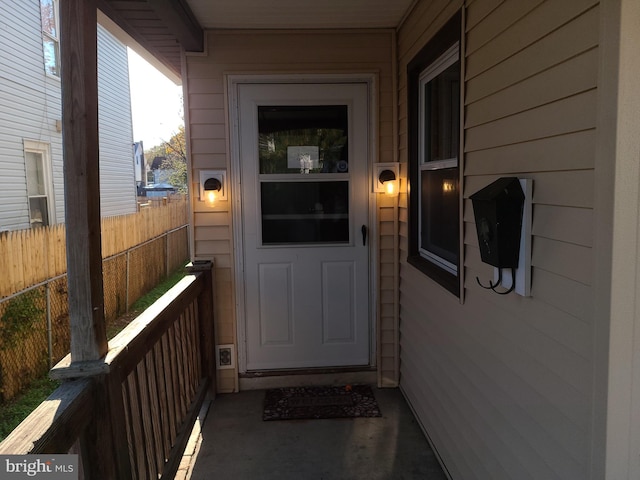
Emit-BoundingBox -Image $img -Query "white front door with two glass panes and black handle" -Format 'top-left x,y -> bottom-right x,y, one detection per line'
237,83 -> 371,371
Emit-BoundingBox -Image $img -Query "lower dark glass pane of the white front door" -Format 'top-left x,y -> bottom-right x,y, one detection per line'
260,181 -> 349,245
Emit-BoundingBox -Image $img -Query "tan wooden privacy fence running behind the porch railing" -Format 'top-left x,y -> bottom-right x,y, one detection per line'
0,197 -> 189,401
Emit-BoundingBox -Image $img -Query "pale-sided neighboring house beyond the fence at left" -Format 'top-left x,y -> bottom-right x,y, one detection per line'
0,0 -> 136,231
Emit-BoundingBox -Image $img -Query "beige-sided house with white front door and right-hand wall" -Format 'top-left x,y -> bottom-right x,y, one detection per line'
53,0 -> 640,480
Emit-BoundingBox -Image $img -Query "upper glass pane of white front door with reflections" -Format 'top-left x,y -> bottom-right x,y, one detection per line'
258,105 -> 349,174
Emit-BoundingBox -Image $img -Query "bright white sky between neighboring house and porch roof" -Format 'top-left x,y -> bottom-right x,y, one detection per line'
127,48 -> 184,150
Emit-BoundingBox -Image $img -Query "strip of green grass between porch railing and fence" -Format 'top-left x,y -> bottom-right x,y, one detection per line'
0,268 -> 185,441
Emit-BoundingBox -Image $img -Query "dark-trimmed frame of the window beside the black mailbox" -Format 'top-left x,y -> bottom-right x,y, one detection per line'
407,12 -> 463,296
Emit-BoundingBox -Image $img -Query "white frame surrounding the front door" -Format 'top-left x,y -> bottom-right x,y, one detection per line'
225,74 -> 378,373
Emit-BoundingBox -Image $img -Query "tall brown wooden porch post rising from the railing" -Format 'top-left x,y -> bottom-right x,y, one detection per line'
60,0 -> 108,364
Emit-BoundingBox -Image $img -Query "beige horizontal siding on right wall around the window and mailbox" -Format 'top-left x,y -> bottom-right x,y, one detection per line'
398,0 -> 600,480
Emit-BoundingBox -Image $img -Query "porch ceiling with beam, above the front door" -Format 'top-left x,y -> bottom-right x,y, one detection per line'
97,0 -> 415,76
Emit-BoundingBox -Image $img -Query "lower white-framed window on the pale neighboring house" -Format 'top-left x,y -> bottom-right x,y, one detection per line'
24,140 -> 55,228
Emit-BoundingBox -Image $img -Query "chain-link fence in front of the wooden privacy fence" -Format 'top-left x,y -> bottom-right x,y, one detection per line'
0,225 -> 189,402
